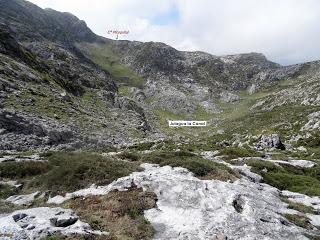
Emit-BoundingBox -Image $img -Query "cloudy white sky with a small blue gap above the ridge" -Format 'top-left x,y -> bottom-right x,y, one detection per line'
31,0 -> 320,65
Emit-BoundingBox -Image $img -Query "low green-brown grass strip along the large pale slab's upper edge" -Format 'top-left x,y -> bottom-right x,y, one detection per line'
141,150 -> 237,181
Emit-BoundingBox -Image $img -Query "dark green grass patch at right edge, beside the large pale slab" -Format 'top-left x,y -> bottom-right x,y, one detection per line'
246,160 -> 320,196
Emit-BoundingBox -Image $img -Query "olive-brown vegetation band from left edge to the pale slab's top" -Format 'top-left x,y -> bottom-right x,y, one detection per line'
0,152 -> 142,197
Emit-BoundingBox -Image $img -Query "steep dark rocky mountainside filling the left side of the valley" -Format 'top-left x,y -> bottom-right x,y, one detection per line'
0,0 -> 156,151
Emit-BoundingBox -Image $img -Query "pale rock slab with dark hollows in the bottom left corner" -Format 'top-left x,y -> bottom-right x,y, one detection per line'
0,207 -> 107,240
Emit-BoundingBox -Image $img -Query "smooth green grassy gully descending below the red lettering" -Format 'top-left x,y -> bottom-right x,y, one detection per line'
80,43 -> 145,88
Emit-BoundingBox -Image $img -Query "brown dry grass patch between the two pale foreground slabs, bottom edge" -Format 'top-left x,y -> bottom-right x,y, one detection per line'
65,187 -> 157,240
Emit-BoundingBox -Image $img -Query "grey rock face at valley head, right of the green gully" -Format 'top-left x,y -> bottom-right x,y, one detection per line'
106,40 -> 280,115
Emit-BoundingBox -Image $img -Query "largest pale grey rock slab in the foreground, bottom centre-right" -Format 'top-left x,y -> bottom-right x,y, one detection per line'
51,164 -> 316,240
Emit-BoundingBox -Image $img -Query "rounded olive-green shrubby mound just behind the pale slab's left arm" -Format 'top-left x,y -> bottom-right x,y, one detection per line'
31,152 -> 142,193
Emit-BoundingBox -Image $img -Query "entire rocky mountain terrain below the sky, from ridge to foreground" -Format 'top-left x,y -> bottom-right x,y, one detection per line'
0,0 -> 320,239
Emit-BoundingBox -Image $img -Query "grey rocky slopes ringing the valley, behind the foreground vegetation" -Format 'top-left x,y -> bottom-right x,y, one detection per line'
0,0 -> 319,150
